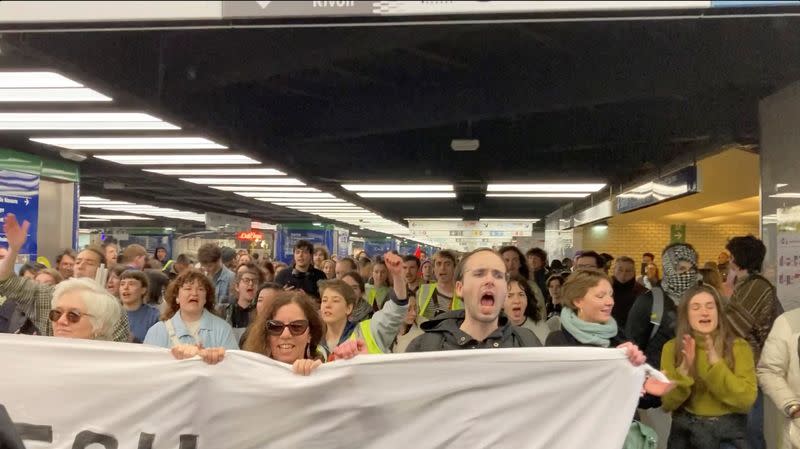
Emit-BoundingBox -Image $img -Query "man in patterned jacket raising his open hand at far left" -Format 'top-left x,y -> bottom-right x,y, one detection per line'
0,214 -> 131,342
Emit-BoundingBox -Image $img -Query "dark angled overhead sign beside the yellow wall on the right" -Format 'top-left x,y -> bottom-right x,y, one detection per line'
617,165 -> 699,213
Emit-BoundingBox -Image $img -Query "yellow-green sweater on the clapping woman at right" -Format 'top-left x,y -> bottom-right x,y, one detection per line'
661,338 -> 758,416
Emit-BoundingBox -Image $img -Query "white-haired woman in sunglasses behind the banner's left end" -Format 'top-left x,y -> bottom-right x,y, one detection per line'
49,278 -> 122,340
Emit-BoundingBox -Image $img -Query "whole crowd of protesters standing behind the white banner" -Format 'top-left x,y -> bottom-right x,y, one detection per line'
0,210 -> 800,449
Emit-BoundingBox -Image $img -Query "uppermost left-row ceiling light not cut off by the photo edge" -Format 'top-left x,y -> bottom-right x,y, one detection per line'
30,137 -> 228,151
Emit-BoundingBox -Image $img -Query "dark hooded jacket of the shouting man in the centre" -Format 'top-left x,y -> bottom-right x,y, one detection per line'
406,310 -> 542,352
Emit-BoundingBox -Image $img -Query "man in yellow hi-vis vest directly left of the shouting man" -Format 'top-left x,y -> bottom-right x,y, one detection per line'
417,250 -> 464,320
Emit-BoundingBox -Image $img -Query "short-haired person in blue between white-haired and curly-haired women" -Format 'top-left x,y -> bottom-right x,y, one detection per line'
119,270 -> 159,343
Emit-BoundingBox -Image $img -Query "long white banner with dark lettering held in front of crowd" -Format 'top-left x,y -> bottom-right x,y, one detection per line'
0,335 -> 644,449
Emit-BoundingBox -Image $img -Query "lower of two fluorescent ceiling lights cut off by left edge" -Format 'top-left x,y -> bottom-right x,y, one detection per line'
0,112 -> 180,130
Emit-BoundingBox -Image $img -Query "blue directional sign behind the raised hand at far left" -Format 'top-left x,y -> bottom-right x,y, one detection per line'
0,170 -> 39,260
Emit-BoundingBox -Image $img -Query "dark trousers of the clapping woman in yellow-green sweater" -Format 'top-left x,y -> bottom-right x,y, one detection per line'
667,411 -> 750,449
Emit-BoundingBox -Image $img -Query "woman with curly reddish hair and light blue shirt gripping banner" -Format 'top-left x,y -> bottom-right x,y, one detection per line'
144,270 -> 239,364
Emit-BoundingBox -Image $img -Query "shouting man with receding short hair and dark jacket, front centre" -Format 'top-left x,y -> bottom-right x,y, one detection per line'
406,248 -> 542,352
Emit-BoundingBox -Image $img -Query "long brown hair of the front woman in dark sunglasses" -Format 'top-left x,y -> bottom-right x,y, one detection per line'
242,292 -> 325,359
